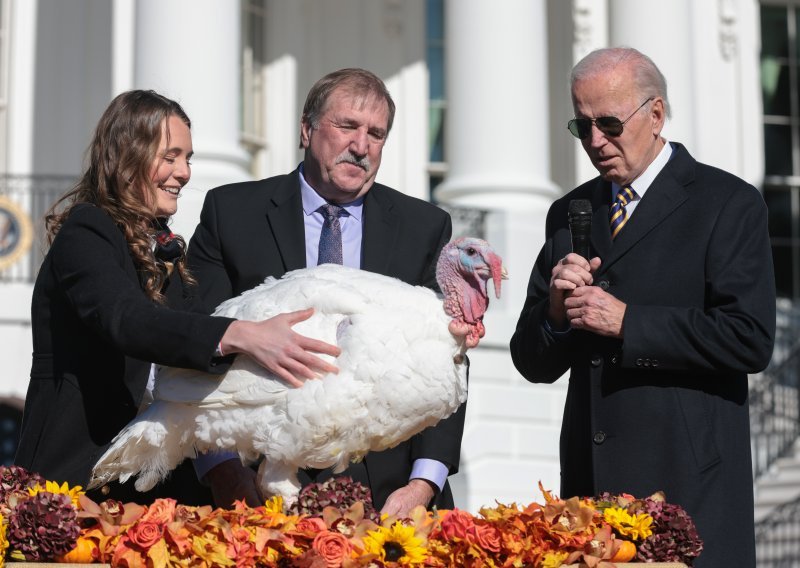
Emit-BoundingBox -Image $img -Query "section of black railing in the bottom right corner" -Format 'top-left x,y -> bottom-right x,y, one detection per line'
756,499 -> 800,568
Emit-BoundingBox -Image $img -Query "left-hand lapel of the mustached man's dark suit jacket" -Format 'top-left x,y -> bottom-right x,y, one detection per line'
266,171 -> 306,272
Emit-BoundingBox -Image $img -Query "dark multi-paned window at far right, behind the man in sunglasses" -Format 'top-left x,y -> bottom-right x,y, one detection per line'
761,2 -> 800,299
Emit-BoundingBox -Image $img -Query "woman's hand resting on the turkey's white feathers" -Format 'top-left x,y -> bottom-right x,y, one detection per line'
220,308 -> 341,387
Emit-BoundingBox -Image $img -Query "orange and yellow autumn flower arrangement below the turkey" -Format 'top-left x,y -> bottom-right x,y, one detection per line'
0,466 -> 702,568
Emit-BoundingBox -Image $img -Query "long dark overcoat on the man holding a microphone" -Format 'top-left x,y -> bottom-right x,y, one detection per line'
511,144 -> 775,567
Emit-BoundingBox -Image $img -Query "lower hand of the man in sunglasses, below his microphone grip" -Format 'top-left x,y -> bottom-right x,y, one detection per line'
564,286 -> 627,337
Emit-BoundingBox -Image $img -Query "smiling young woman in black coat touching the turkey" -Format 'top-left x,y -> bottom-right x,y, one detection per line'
16,91 -> 338,504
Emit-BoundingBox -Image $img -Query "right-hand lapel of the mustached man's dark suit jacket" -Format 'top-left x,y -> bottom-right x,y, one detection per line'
361,183 -> 398,274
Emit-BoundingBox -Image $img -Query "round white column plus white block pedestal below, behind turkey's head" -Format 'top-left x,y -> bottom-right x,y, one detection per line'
436,0 -> 566,511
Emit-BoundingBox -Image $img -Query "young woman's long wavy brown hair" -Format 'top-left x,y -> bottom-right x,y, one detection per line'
45,90 -> 194,303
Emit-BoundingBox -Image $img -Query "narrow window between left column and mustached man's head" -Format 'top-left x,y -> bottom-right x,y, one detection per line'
239,0 -> 267,177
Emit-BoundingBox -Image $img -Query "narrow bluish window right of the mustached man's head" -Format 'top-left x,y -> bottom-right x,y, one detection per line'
425,0 -> 447,202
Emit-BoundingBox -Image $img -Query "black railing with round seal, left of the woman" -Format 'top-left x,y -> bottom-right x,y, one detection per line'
0,174 -> 75,283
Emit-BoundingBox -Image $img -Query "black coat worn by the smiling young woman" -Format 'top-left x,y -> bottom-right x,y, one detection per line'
15,205 -> 232,504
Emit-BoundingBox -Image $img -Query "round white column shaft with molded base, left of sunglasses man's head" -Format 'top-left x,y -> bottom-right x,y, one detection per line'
436,0 -> 559,211
